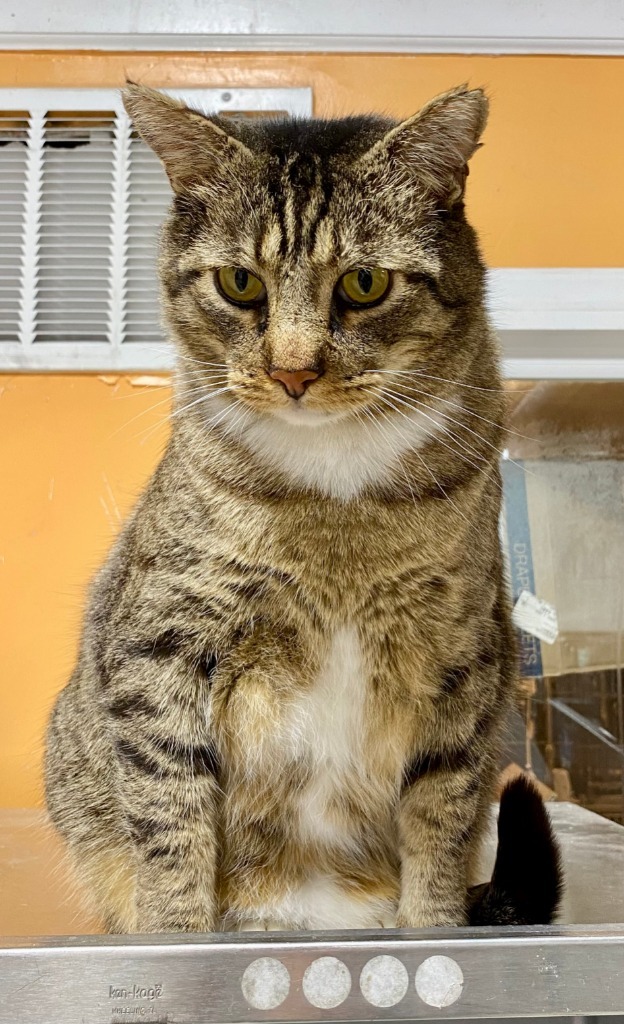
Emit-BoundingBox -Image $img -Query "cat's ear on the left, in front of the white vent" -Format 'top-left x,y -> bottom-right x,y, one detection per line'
122,82 -> 253,193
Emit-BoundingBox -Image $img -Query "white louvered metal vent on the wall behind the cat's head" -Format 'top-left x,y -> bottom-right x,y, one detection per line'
0,89 -> 311,370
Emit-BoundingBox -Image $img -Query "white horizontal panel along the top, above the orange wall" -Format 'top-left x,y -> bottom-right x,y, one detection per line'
0,0 -> 624,53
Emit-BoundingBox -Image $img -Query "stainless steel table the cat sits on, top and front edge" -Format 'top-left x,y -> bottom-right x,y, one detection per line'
0,804 -> 624,1024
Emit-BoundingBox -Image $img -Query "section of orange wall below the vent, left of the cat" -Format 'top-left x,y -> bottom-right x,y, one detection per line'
0,375 -> 169,807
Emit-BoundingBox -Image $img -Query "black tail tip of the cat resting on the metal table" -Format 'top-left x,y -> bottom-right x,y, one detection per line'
468,775 -> 564,925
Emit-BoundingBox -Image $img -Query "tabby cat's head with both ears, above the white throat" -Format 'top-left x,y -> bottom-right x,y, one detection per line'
126,87 -> 486,426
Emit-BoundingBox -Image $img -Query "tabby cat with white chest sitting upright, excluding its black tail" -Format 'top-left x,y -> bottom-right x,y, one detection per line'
46,85 -> 561,932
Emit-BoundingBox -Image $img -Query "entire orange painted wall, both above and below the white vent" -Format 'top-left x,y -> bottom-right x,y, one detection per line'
0,53 -> 624,806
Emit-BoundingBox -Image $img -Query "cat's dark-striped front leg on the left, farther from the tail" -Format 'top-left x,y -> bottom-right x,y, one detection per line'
108,667 -> 220,932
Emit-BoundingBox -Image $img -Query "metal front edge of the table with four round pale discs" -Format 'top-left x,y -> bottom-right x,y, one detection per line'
0,926 -> 624,1024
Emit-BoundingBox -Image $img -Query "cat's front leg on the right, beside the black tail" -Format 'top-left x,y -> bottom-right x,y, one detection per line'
397,750 -> 490,928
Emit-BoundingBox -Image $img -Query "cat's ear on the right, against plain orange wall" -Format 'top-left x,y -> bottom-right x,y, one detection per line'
360,86 -> 489,207
